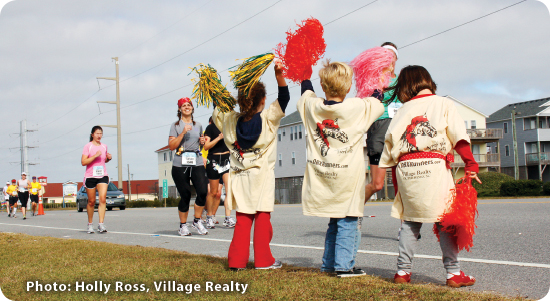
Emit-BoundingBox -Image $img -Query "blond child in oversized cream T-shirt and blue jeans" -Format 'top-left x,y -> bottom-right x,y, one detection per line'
297,60 -> 384,278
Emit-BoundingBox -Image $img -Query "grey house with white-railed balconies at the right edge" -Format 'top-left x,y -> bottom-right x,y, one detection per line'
487,98 -> 550,182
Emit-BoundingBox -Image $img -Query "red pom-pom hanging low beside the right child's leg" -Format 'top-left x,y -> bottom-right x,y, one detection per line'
433,177 -> 478,252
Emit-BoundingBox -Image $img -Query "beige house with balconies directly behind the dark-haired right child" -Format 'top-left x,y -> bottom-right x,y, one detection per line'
445,96 -> 503,179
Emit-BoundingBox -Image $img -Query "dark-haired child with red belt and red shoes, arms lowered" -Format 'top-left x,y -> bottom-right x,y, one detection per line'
380,66 -> 481,287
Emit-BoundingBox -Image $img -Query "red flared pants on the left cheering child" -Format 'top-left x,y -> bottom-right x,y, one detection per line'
228,212 -> 275,268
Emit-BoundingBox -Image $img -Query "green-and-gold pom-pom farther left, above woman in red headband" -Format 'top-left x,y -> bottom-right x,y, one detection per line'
191,64 -> 235,113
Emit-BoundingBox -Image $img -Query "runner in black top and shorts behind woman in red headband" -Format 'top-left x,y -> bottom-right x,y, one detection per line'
204,117 -> 235,229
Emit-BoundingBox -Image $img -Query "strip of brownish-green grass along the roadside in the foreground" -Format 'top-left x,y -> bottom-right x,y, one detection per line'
0,233 -> 523,301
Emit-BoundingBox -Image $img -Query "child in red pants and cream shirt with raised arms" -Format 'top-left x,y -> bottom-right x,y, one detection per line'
212,62 -> 290,271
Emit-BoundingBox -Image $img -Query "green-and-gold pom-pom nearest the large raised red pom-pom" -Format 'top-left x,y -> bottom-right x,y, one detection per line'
229,53 -> 275,97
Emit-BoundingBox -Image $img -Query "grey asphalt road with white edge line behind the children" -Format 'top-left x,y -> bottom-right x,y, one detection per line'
0,198 -> 550,299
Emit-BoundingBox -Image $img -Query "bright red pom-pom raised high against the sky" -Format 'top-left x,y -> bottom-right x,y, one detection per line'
275,18 -> 327,83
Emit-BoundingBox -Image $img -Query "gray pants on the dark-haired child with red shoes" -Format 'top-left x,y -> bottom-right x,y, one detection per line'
397,221 -> 460,273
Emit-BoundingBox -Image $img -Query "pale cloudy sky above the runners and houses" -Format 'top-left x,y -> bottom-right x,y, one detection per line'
0,0 -> 550,182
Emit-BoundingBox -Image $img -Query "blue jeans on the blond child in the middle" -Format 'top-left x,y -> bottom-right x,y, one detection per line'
321,216 -> 363,272
